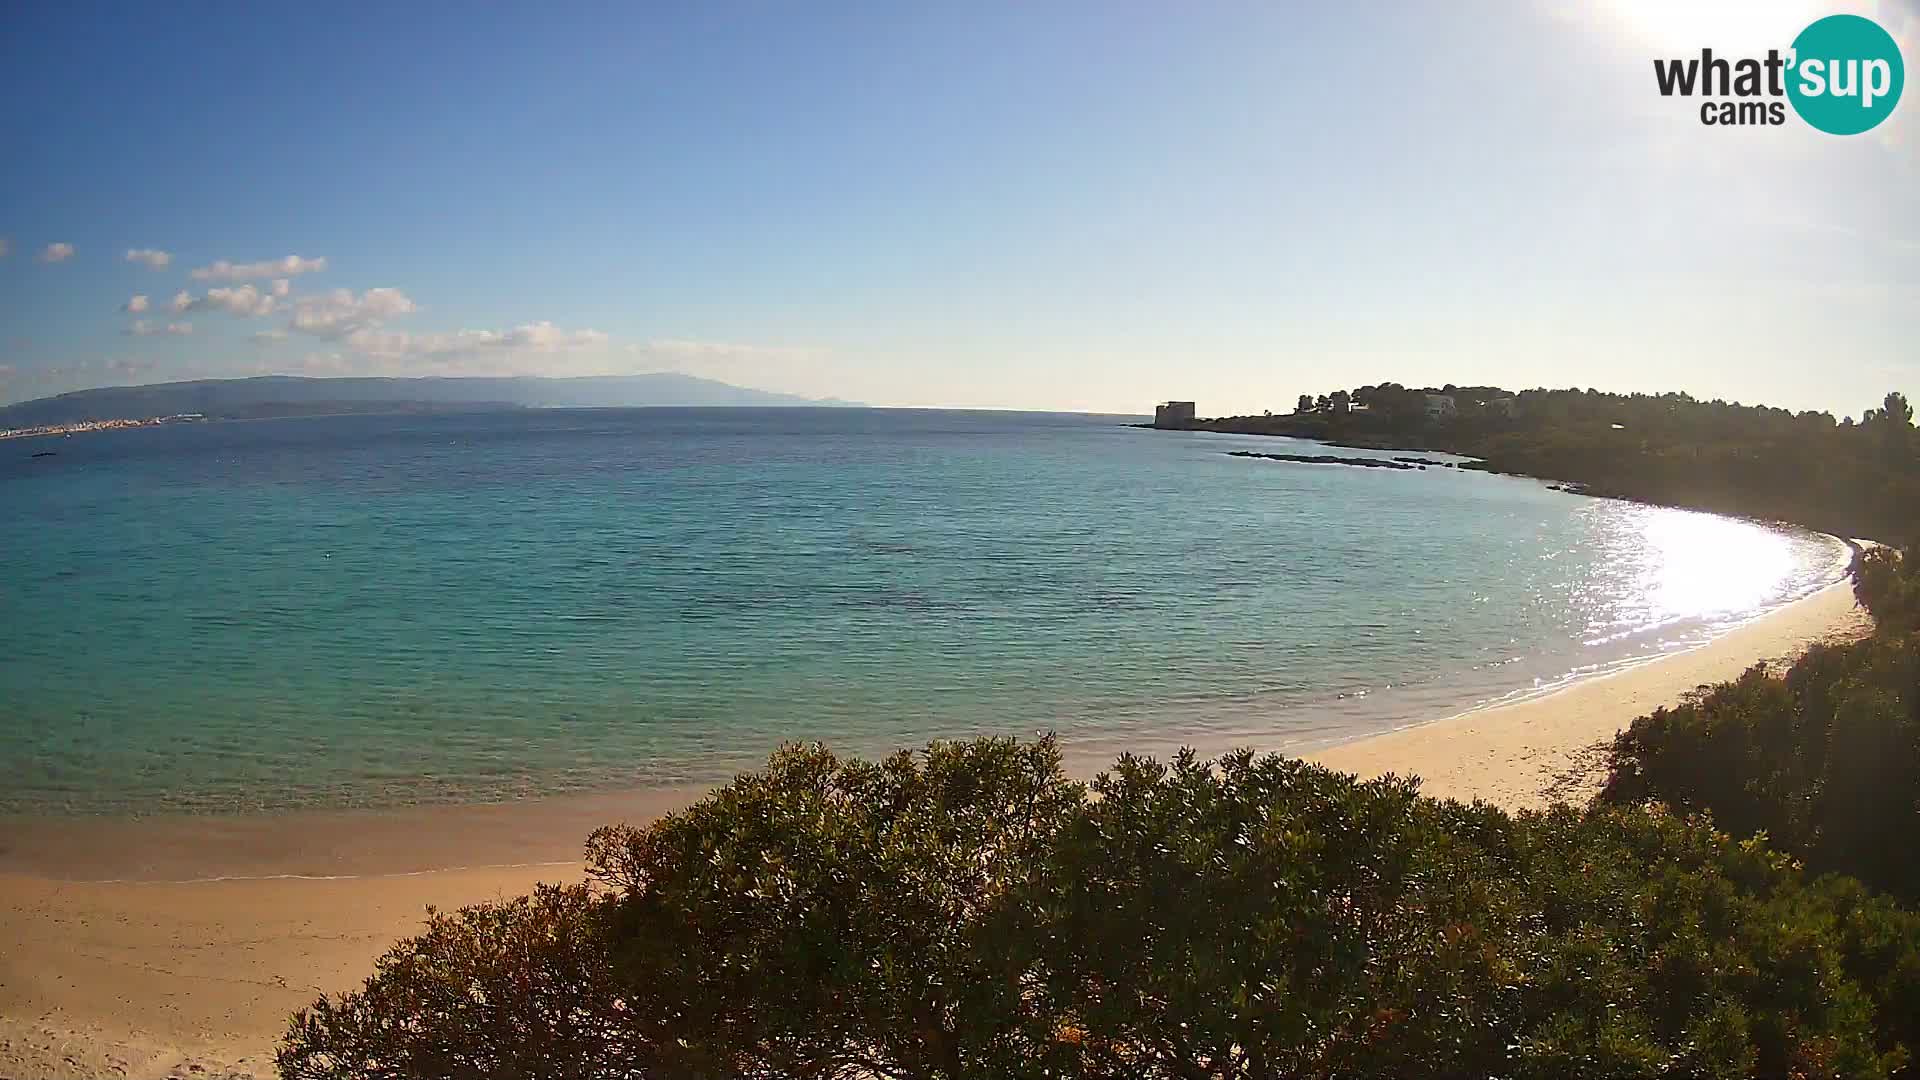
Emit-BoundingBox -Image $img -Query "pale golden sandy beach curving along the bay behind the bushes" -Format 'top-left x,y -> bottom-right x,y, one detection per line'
0,582 -> 1866,1080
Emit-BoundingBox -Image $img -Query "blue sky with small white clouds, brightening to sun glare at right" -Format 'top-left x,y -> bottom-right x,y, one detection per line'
0,0 -> 1920,413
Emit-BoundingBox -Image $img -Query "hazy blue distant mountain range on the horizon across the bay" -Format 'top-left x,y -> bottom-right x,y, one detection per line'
0,371 -> 854,420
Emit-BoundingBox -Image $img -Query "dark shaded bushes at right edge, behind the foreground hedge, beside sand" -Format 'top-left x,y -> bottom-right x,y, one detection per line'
1601,550 -> 1920,901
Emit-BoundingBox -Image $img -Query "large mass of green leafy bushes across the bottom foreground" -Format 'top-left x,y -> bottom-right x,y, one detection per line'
280,740 -> 1920,1080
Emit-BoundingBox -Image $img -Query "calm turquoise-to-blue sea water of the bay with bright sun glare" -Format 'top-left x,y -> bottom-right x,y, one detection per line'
0,409 -> 1845,813
